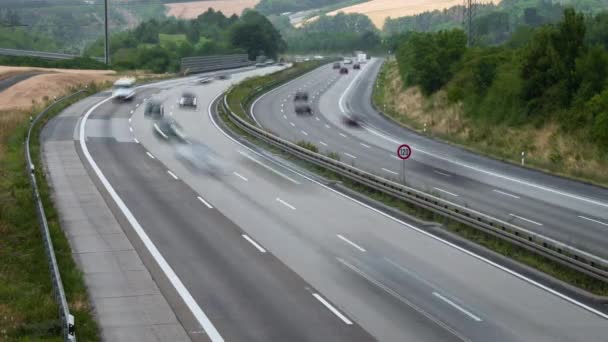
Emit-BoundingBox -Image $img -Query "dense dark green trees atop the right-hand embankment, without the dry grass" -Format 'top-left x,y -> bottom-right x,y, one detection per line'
397,9 -> 608,150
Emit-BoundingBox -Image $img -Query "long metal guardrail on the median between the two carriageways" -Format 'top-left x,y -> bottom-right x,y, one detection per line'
222,88 -> 608,282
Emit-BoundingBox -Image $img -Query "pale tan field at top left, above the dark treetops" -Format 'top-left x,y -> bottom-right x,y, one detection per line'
166,0 -> 260,19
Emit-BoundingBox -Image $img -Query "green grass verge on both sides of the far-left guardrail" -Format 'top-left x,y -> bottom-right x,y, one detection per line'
0,84 -> 104,341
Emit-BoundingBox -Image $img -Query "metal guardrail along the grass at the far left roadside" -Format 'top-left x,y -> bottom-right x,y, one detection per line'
25,90 -> 84,341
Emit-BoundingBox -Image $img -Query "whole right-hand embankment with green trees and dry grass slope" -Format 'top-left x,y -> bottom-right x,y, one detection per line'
374,9 -> 608,185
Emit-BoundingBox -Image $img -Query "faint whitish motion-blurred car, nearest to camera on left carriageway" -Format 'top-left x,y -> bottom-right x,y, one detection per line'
176,143 -> 224,176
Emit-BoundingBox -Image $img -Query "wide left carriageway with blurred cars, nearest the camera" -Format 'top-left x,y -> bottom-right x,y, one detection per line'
66,63 -> 608,341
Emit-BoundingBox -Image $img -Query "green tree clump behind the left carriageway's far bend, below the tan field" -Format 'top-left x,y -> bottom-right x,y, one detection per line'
86,9 -> 286,72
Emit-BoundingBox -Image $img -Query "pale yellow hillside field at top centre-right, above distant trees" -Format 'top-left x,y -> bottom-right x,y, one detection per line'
311,0 -> 496,28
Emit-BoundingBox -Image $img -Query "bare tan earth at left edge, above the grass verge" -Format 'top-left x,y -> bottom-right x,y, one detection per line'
0,67 -> 117,112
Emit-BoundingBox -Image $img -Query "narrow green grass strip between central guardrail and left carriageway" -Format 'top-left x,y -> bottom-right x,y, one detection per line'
219,67 -> 608,296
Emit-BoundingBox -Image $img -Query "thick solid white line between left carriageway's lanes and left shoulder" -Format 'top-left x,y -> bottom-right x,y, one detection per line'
79,97 -> 224,342
